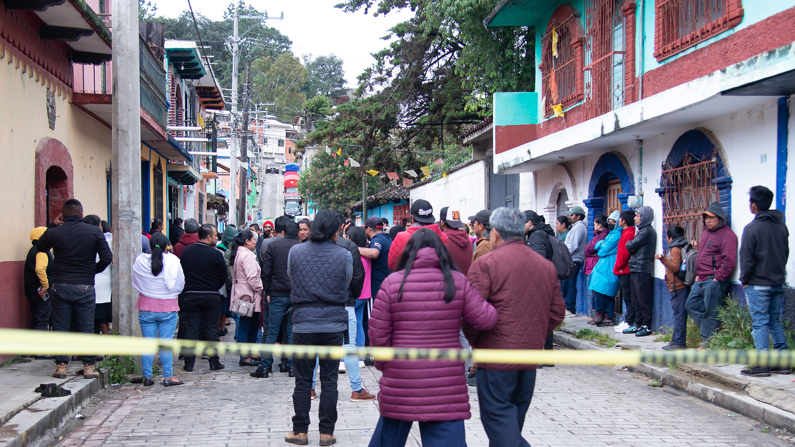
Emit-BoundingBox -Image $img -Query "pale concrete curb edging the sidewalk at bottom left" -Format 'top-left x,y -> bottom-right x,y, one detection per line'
0,371 -> 110,447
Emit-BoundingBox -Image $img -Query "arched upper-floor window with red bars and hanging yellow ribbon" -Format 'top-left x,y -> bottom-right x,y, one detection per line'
539,5 -> 584,117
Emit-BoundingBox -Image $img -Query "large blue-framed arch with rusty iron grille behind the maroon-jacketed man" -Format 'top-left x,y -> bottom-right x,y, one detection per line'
657,129 -> 732,246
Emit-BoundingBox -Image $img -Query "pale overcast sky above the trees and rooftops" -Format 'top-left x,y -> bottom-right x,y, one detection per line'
152,0 -> 411,87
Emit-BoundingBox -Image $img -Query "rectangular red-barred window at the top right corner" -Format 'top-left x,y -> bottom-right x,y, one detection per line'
654,0 -> 743,61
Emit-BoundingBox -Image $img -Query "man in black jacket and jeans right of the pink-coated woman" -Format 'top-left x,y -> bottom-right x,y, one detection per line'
250,217 -> 301,379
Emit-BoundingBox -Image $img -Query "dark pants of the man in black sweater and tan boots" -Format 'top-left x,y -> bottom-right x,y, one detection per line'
50,284 -> 97,365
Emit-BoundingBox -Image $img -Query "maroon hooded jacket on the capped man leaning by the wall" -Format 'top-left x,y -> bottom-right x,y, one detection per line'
696,202 -> 737,282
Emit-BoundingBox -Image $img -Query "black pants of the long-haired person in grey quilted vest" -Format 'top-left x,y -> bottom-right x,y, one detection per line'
293,332 -> 342,435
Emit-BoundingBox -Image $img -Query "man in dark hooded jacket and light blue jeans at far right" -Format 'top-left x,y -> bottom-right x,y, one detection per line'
740,186 -> 789,377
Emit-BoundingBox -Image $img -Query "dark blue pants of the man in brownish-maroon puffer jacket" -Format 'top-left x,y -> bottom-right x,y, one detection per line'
478,368 -> 536,447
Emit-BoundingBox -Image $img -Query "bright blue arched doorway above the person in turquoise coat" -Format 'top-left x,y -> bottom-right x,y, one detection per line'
583,152 -> 635,233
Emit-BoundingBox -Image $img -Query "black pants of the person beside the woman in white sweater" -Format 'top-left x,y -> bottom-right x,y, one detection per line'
179,292 -> 221,366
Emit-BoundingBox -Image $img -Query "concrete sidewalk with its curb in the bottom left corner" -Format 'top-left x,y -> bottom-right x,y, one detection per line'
0,357 -> 108,447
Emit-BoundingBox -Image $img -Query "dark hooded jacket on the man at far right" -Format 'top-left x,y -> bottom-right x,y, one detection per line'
740,210 -> 789,286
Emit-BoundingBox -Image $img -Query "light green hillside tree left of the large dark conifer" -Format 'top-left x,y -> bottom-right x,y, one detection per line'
251,53 -> 308,123
